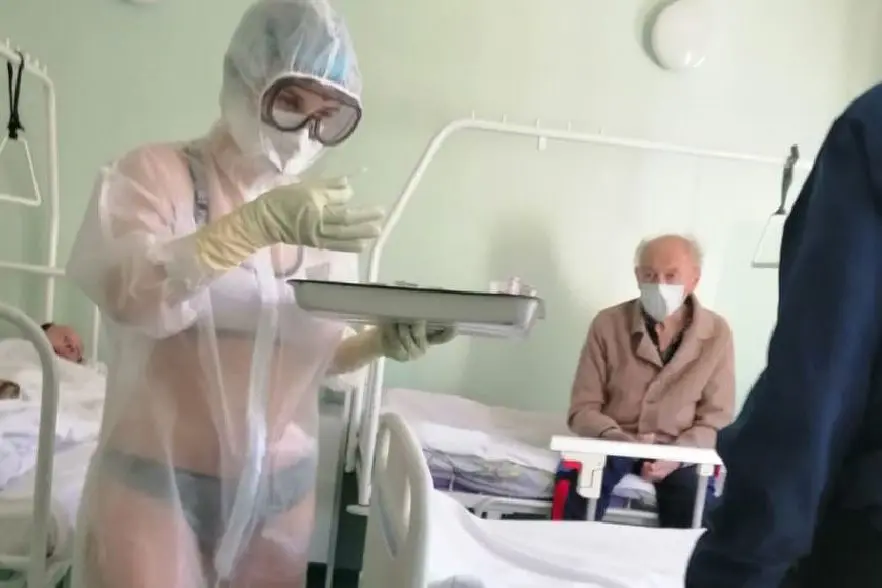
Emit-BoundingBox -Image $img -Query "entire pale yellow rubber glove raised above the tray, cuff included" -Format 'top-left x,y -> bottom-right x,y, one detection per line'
195,178 -> 384,271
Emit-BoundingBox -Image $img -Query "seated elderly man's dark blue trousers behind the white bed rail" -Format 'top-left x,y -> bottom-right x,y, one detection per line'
564,456 -> 714,529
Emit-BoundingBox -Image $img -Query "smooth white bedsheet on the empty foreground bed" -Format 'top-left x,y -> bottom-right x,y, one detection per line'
427,491 -> 703,588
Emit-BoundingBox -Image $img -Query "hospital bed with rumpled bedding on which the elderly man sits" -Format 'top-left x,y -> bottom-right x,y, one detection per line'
328,296 -> 656,524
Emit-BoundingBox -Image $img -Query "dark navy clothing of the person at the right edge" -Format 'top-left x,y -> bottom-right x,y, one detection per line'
686,86 -> 882,588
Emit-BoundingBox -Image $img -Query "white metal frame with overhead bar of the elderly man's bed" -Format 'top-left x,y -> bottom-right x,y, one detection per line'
326,113 -> 813,588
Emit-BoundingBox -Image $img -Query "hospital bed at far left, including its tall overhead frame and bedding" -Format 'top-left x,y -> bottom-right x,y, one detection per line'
0,40 -> 105,588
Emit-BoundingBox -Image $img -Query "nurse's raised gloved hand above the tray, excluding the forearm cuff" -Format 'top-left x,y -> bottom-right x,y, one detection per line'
249,178 -> 385,253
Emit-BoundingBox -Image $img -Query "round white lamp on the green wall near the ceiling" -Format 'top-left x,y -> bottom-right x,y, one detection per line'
650,0 -> 715,71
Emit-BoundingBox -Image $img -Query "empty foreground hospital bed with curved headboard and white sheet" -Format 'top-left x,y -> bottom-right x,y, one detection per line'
360,413 -> 719,588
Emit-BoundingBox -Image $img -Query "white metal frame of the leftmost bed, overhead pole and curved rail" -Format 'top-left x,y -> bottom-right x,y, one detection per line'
0,39 -> 101,588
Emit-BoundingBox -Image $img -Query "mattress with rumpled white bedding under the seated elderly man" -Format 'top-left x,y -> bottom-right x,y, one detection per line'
383,388 -> 655,508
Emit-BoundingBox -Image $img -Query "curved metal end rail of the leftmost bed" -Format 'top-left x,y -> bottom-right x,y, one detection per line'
0,303 -> 59,588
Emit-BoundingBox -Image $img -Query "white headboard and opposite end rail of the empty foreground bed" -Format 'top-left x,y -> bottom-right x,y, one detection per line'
359,413 -> 720,588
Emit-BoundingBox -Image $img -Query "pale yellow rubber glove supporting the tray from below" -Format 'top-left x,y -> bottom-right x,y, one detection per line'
330,321 -> 456,374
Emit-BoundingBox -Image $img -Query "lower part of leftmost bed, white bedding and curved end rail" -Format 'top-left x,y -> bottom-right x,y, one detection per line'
0,304 -> 105,588
